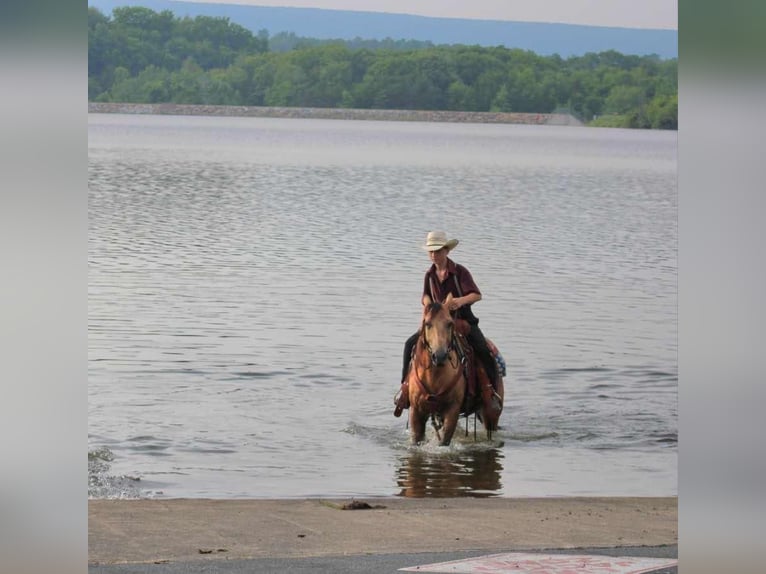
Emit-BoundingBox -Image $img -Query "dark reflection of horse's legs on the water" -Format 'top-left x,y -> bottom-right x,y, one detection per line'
396,448 -> 503,498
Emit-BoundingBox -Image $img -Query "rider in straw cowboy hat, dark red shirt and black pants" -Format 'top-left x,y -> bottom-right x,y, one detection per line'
394,231 -> 501,417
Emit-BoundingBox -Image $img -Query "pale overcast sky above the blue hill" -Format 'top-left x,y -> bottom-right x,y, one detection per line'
183,0 -> 678,30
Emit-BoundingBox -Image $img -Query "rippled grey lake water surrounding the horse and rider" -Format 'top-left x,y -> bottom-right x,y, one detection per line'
88,115 -> 678,498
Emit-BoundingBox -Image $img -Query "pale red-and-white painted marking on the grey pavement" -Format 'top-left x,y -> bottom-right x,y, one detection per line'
399,552 -> 678,574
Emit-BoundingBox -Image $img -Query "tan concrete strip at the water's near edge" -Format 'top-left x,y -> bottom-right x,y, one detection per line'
88,496 -> 678,565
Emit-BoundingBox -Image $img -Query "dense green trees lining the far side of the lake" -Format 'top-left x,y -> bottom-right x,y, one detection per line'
88,7 -> 678,129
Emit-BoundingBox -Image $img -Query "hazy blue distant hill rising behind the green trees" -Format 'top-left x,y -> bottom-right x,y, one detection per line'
88,0 -> 678,58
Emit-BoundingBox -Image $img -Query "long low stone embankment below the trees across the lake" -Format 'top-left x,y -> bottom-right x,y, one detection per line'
88,102 -> 584,126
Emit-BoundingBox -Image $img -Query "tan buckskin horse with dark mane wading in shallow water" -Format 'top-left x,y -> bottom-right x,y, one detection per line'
407,294 -> 503,446
